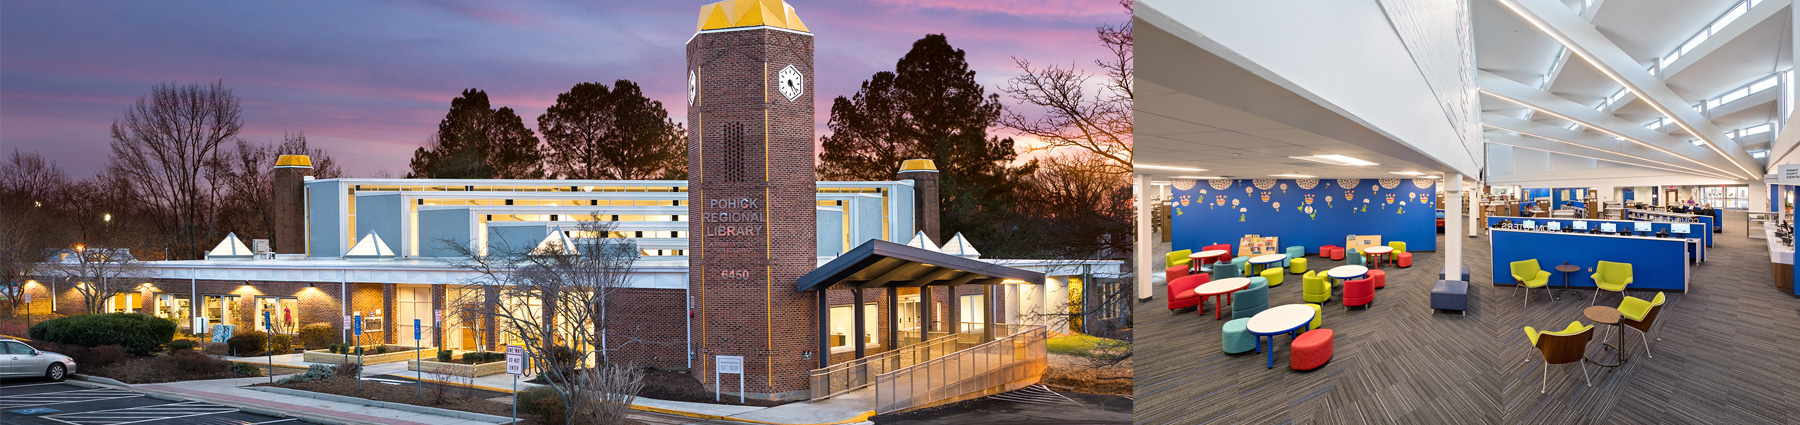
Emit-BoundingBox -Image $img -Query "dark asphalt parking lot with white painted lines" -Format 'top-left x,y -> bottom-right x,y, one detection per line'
0,380 -> 299,425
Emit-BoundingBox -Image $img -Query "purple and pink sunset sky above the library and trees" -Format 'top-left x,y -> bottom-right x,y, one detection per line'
0,0 -> 1129,178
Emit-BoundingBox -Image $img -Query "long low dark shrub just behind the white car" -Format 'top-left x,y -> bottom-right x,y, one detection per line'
29,313 -> 175,355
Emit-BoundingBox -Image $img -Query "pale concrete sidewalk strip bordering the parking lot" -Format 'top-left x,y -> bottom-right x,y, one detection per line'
133,376 -> 504,425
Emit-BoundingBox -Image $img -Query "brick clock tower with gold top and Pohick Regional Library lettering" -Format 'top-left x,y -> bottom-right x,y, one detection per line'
684,0 -> 824,400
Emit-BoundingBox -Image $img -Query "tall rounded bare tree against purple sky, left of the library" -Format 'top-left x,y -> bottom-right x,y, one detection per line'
110,81 -> 243,258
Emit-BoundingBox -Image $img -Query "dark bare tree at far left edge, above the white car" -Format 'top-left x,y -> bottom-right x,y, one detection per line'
0,149 -> 68,313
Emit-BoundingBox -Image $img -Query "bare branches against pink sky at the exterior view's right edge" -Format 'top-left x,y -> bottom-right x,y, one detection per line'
1001,0 -> 1132,175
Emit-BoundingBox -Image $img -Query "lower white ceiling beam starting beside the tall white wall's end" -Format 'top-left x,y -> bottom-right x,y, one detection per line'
1476,70 -> 1742,175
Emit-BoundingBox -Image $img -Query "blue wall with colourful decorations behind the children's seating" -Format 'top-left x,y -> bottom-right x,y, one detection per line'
1170,178 -> 1438,252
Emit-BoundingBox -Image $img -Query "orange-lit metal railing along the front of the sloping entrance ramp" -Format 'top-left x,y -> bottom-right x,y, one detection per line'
875,326 -> 1049,414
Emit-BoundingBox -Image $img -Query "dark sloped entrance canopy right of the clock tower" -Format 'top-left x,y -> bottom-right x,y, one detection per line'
797,240 -> 1044,292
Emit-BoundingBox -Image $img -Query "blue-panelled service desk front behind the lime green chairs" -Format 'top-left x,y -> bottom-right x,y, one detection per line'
1489,229 -> 1692,292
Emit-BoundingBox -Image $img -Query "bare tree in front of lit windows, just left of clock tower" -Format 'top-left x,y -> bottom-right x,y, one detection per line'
439,222 -> 668,421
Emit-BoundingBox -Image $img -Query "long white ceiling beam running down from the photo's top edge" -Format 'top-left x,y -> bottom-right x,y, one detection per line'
1496,0 -> 1762,180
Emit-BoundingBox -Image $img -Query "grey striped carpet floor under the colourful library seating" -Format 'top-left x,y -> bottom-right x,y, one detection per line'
1134,213 -> 1800,423
